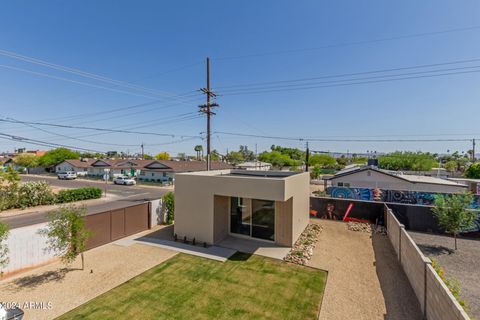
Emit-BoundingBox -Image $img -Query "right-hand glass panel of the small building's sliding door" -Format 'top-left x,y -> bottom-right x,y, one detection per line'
252,199 -> 275,241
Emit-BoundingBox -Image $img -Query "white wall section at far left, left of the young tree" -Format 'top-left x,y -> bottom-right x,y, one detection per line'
3,223 -> 55,273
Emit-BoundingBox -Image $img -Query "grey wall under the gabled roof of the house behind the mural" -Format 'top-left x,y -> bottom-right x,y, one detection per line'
331,170 -> 465,193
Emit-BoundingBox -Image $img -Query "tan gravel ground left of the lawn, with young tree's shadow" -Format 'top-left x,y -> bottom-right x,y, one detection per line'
0,244 -> 176,320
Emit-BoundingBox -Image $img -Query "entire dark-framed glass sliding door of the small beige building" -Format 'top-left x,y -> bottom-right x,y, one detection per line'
230,197 -> 275,241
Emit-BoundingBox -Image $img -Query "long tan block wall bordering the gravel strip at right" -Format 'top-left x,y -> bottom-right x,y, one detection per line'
384,205 -> 470,320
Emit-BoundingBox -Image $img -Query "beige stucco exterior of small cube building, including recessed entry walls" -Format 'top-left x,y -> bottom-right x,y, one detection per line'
174,170 -> 309,246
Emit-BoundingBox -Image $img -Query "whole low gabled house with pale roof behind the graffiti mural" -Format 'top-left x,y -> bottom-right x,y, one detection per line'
326,166 -> 467,193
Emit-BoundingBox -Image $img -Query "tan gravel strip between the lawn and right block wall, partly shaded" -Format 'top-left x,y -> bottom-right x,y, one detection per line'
309,219 -> 422,320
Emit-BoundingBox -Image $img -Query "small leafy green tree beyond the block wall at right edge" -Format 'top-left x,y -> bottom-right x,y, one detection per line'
432,192 -> 478,250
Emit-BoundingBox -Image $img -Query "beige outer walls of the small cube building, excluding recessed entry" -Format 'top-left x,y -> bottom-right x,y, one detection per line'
174,170 -> 309,243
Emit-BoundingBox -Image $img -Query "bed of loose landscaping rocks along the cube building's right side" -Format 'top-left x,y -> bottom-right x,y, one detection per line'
284,223 -> 322,265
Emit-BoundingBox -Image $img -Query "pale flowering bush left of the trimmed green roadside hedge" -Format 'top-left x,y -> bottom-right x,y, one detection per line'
16,181 -> 55,209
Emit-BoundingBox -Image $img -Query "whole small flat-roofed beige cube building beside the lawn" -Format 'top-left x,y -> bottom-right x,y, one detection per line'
174,170 -> 310,247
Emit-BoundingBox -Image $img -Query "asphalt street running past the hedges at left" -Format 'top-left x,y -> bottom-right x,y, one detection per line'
0,175 -> 171,229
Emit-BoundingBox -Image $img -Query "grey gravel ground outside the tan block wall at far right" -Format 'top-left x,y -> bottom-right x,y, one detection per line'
408,231 -> 480,319
